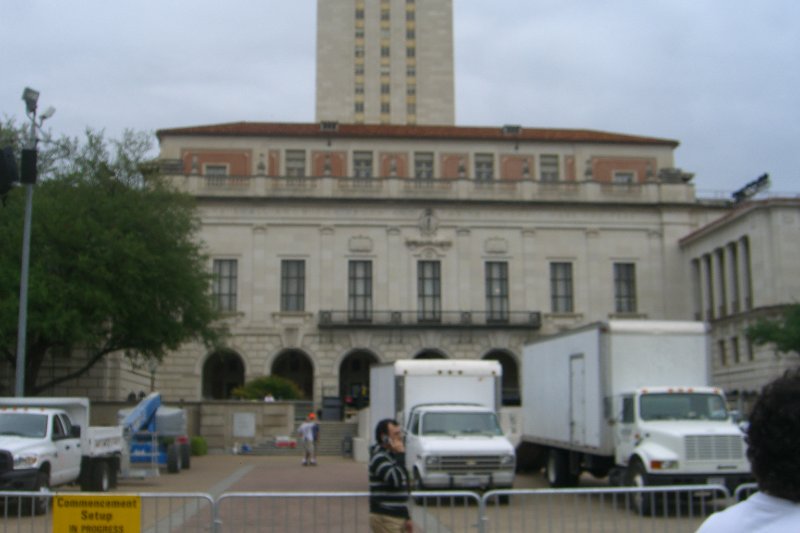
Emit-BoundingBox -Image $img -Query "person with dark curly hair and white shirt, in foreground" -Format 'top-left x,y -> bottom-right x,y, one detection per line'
697,368 -> 800,533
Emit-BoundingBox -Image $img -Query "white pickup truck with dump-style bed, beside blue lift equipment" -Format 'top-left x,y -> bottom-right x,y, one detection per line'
0,398 -> 126,514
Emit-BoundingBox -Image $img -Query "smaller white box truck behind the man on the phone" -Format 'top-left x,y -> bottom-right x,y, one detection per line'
370,359 -> 515,490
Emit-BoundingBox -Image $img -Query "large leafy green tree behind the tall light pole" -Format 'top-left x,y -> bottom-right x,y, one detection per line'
0,123 -> 224,395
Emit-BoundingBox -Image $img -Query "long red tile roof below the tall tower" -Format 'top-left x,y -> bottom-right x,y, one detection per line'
156,122 -> 679,148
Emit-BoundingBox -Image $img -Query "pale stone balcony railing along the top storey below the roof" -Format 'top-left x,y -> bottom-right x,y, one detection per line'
158,168 -> 695,204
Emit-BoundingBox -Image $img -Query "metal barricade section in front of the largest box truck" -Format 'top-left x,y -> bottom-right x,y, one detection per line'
479,485 -> 730,533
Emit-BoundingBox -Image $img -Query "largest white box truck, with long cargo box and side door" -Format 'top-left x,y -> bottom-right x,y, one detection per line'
517,320 -> 752,502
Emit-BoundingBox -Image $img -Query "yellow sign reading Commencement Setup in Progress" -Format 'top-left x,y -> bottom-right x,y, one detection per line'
53,494 -> 142,533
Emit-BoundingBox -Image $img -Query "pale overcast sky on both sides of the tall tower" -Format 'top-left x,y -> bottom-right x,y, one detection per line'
0,0 -> 800,195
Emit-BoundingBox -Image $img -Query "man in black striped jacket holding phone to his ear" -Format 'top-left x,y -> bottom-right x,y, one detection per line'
369,418 -> 413,533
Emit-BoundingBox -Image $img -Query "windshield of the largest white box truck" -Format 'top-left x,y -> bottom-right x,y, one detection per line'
639,392 -> 728,420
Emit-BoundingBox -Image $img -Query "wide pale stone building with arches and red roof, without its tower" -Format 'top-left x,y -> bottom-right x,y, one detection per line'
142,123 -> 726,404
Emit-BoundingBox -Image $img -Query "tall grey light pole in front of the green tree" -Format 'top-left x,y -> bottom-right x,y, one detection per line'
15,87 -> 55,397
